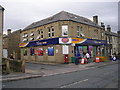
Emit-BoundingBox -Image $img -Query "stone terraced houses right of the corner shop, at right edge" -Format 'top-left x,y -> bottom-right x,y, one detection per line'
105,25 -> 119,56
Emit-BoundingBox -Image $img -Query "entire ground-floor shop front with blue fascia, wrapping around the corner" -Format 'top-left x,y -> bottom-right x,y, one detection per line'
19,37 -> 106,63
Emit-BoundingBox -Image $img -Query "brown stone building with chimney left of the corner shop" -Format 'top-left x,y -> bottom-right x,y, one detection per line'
3,29 -> 21,59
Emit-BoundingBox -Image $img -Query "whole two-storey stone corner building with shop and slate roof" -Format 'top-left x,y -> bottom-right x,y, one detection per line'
19,11 -> 106,63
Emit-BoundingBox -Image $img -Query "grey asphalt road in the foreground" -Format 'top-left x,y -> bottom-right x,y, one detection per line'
3,64 -> 118,90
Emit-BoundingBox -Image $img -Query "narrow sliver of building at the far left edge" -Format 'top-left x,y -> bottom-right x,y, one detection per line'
0,5 -> 4,61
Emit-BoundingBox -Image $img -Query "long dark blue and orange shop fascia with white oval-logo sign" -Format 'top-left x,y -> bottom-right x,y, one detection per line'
19,37 -> 107,47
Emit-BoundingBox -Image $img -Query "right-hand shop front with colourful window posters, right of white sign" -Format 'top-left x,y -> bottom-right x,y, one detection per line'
72,38 -> 106,58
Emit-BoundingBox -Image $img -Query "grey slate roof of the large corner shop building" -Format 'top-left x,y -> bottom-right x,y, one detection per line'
23,11 -> 100,30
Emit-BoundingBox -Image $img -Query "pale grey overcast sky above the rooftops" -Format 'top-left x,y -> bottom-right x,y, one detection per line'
1,0 -> 118,33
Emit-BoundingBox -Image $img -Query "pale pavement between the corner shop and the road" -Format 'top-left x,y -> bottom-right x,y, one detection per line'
0,61 -> 118,82
